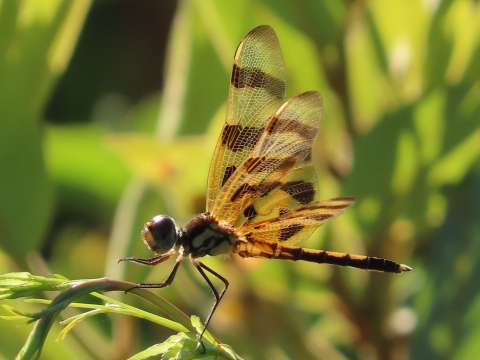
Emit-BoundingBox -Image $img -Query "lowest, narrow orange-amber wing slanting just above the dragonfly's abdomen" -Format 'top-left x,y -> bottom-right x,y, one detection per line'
237,197 -> 355,246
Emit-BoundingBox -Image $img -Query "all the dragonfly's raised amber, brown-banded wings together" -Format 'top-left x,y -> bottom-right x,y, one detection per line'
207,26 -> 354,249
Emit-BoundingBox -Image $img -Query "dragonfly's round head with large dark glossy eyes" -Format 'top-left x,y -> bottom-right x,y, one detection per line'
142,215 -> 177,254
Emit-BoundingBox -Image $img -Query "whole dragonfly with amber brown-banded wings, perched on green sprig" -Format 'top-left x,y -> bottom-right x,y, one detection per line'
119,25 -> 412,338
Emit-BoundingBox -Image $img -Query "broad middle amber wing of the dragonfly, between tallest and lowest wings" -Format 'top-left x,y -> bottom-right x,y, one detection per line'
211,92 -> 322,228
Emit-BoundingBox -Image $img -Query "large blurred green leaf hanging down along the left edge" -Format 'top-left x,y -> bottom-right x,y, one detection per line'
0,0 -> 90,259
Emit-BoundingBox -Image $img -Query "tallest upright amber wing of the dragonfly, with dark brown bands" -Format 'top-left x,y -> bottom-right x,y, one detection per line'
207,25 -> 286,214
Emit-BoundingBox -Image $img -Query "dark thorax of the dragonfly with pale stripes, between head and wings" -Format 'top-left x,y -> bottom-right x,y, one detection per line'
180,213 -> 238,258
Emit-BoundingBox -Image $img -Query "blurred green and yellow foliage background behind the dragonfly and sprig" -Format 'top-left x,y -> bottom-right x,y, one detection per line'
0,0 -> 480,359
